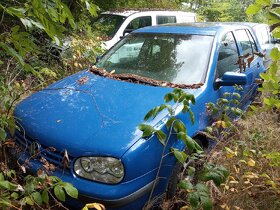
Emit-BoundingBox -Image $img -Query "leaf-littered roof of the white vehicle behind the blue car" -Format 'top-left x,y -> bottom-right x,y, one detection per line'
101,9 -> 196,17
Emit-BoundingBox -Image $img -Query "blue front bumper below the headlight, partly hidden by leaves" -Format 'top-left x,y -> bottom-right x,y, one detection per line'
15,144 -> 161,209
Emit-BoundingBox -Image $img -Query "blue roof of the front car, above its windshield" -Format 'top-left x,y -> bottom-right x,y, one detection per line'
132,22 -> 247,36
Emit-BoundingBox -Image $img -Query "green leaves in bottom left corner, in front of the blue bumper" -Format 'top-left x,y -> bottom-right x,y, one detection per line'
0,170 -> 78,208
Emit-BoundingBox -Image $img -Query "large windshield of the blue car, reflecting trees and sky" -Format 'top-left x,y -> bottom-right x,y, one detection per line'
96,34 -> 213,85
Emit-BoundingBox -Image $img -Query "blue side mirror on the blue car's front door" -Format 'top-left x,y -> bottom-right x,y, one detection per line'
214,72 -> 247,89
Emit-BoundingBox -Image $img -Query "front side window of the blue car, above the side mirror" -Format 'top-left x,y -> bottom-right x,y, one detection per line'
217,32 -> 239,78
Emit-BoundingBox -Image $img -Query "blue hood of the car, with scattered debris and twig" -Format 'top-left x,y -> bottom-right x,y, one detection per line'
15,71 -> 201,157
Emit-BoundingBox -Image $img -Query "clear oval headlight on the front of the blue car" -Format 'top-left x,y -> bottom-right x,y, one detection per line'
74,157 -> 124,184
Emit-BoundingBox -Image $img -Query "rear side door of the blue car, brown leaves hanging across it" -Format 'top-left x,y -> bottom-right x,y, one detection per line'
234,29 -> 263,107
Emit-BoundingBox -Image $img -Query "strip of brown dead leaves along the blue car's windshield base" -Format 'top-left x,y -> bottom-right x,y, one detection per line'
88,66 -> 203,89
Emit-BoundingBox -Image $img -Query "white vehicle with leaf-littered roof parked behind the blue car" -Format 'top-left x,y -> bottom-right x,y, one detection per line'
94,10 -> 196,49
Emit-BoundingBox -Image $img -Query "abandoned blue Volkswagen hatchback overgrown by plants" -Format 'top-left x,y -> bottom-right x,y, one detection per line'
14,23 -> 264,209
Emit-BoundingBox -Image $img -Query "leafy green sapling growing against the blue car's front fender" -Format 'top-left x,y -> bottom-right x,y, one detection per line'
138,89 -> 230,210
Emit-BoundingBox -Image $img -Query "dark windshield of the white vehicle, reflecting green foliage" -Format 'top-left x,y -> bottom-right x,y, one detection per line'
93,14 -> 126,38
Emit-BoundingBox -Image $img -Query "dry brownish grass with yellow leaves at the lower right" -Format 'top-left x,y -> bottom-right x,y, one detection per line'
209,112 -> 280,210
